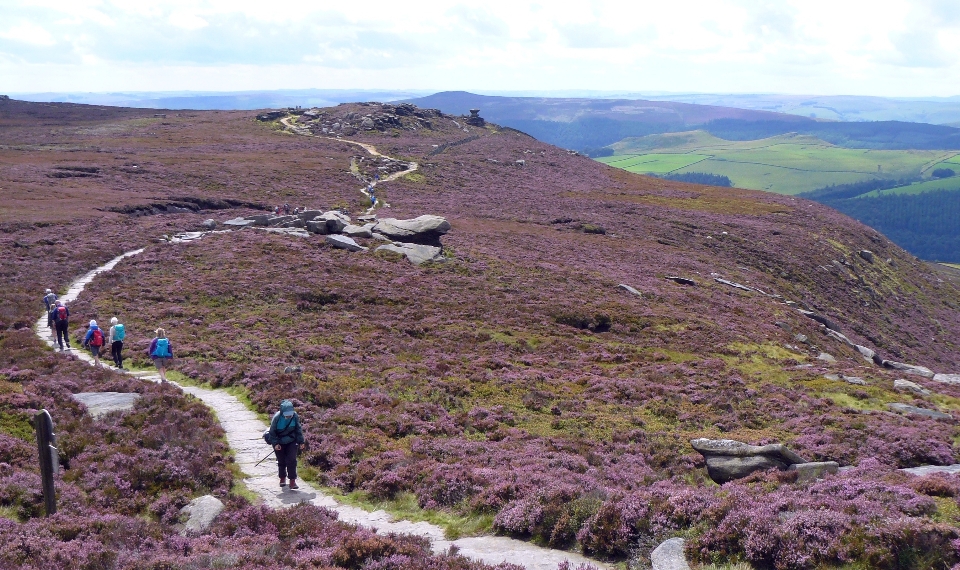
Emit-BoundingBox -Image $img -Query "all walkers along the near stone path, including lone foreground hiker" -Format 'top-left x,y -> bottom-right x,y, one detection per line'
43,289 -> 304,482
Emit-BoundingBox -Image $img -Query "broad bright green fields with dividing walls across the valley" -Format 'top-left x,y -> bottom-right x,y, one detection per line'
598,131 -> 960,194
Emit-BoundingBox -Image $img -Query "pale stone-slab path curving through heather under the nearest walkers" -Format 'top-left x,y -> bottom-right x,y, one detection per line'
34,249 -> 612,570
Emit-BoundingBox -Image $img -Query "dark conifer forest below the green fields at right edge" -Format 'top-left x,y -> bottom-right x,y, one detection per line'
805,186 -> 960,263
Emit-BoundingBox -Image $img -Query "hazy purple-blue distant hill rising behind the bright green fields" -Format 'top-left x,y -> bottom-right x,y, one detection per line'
409,91 -> 960,151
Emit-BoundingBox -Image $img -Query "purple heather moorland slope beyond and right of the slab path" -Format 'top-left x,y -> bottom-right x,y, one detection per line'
0,102 -> 960,568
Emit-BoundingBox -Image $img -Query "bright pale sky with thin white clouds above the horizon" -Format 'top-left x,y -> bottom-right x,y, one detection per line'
0,0 -> 960,97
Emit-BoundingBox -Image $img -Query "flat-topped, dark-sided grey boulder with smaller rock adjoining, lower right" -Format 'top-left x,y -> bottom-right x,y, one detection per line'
690,438 -> 807,484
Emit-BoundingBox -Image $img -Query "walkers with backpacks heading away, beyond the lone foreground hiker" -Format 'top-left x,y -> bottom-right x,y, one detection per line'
43,289 -> 173,382
